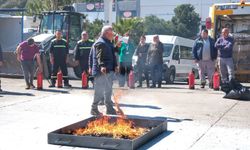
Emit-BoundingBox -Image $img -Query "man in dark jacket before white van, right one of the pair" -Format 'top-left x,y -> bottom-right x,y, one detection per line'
147,35 -> 164,88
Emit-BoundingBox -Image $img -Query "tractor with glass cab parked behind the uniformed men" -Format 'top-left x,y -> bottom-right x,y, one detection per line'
33,11 -> 85,77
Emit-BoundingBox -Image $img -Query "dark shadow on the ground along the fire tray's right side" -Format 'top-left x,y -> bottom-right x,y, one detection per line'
138,131 -> 173,150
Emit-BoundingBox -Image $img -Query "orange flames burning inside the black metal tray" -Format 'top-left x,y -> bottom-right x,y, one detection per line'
73,116 -> 148,139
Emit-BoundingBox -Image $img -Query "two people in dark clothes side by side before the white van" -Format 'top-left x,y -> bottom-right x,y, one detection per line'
135,35 -> 164,88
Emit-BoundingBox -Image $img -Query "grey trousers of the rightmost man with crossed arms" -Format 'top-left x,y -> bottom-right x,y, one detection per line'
219,58 -> 235,83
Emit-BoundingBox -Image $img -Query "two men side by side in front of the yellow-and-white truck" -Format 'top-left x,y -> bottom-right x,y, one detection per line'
193,28 -> 235,88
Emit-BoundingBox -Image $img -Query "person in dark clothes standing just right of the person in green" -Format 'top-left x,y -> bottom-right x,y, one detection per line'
135,35 -> 149,87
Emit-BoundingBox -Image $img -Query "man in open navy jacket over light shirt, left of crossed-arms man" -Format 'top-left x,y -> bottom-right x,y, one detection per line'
192,29 -> 217,88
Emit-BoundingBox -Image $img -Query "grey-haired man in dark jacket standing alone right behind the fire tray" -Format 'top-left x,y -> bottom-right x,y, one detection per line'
90,26 -> 117,115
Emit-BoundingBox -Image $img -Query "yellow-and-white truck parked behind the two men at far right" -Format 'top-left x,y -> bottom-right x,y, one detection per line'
206,1 -> 250,82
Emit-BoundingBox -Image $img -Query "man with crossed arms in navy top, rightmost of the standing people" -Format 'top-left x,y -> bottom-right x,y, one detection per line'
215,28 -> 235,83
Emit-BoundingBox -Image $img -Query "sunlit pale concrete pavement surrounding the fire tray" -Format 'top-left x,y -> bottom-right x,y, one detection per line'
0,78 -> 250,150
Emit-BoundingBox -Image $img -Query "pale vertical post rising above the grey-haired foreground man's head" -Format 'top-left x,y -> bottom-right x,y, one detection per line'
104,0 -> 113,25
